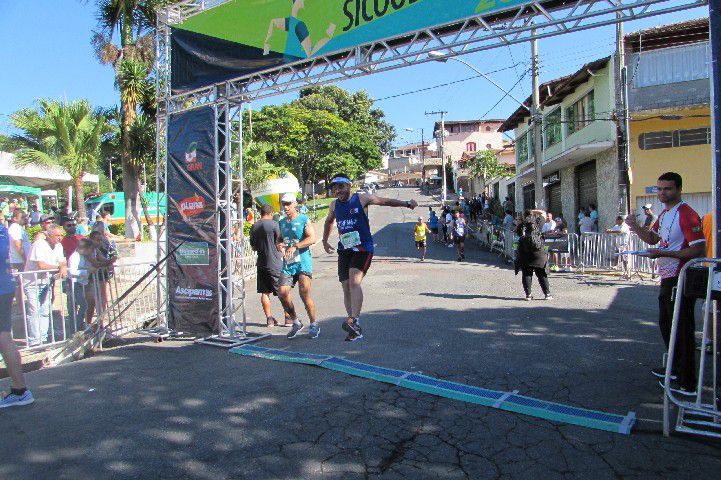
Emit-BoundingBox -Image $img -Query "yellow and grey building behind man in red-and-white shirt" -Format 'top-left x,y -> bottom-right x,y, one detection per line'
626,18 -> 712,215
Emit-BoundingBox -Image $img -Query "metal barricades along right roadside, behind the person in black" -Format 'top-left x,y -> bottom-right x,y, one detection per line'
473,222 -> 656,278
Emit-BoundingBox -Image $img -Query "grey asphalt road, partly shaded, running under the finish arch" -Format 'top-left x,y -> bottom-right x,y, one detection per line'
0,189 -> 721,480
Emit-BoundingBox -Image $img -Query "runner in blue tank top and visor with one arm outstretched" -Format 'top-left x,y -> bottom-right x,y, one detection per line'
323,174 -> 418,342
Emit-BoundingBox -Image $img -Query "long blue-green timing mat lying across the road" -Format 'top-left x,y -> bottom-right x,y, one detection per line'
230,345 -> 636,435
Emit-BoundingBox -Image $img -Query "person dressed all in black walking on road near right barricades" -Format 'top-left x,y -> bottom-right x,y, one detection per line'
516,210 -> 553,300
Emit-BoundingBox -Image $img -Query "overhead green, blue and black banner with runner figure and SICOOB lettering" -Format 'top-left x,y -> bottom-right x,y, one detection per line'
171,0 -> 528,93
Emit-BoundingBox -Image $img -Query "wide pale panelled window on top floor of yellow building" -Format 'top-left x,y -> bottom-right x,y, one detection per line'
633,42 -> 711,88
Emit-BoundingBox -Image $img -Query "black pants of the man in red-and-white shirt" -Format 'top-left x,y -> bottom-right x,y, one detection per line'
658,277 -> 696,390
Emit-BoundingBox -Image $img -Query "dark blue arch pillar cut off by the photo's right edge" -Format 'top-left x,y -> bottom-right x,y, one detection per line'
702,0 -> 721,408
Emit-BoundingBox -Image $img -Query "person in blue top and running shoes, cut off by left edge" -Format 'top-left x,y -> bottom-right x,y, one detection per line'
0,224 -> 35,408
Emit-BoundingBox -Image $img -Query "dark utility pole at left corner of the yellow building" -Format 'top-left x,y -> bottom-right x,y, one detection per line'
615,12 -> 631,215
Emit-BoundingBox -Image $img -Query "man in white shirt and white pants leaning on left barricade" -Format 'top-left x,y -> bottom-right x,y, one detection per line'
24,226 -> 67,346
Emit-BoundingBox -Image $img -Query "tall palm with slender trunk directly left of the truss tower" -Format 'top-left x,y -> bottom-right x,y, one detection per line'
91,0 -> 167,238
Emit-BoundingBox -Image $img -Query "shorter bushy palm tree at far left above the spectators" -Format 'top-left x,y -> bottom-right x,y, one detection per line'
5,100 -> 108,216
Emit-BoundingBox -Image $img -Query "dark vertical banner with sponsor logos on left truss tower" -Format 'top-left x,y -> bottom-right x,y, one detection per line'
167,107 -> 218,336
